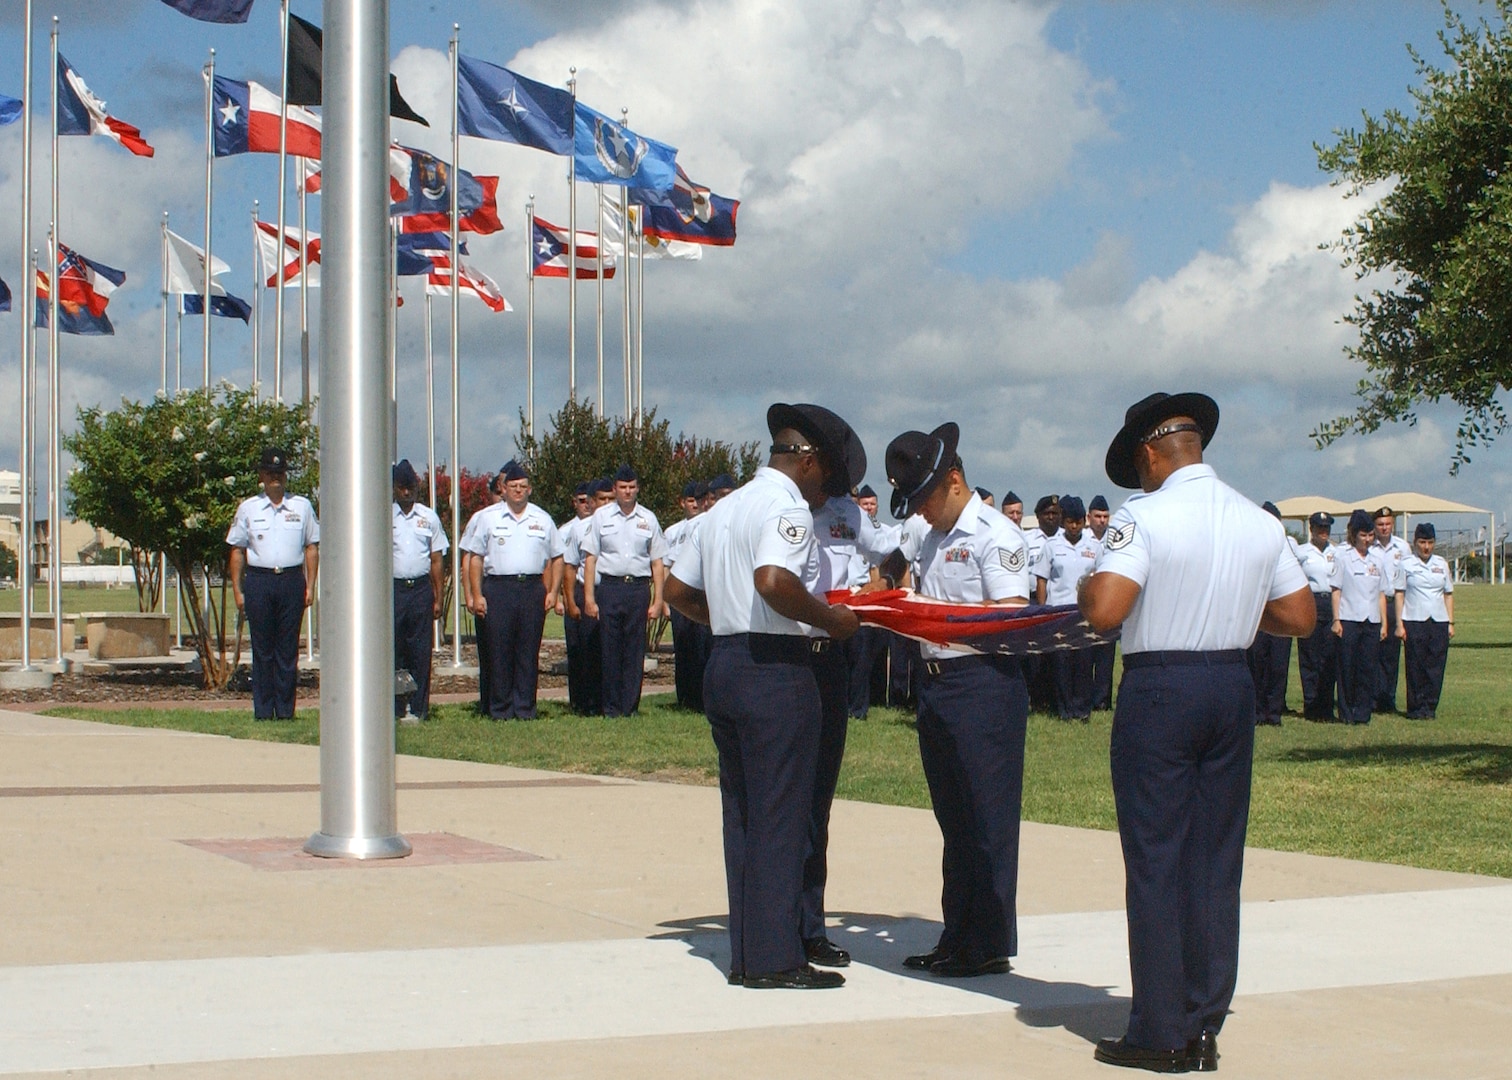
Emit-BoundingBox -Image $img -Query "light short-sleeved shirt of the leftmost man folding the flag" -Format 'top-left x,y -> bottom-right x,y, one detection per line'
671,466 -> 815,637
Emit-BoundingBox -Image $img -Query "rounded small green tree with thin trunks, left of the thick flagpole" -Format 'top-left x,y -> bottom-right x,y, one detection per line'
64,383 -> 319,690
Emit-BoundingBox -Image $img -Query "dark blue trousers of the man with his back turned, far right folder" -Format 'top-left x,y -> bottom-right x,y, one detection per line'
1110,649 -> 1255,1050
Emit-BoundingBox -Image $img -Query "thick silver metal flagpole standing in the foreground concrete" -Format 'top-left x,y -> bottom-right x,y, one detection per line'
304,0 -> 410,859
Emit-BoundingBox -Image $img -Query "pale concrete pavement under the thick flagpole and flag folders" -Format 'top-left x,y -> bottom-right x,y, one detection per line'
0,712 -> 1512,1080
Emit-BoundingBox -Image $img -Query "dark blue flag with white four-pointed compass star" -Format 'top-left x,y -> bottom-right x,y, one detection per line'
457,56 -> 572,156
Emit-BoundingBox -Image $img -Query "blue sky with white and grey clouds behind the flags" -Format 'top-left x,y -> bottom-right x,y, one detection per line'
0,0 -> 1512,525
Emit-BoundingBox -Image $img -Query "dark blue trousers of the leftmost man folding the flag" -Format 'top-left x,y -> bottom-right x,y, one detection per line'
703,634 -> 821,976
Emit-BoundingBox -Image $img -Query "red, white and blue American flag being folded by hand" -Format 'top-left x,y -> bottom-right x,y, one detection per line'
826,588 -> 1119,656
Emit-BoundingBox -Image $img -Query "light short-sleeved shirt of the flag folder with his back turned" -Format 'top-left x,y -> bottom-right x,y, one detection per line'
1096,464 -> 1308,655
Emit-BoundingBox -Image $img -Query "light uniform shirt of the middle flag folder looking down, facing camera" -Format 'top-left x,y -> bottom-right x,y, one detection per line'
915,495 -> 1030,659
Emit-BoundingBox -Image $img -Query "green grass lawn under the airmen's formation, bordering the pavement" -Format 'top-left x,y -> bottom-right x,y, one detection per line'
41,585 -> 1512,877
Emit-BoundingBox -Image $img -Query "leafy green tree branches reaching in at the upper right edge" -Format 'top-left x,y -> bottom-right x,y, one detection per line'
1312,0 -> 1512,472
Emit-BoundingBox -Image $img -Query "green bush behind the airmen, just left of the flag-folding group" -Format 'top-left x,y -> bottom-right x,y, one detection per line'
514,401 -> 761,525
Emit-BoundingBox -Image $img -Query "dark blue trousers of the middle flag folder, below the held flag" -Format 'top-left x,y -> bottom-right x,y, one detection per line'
918,656 -> 1028,961
